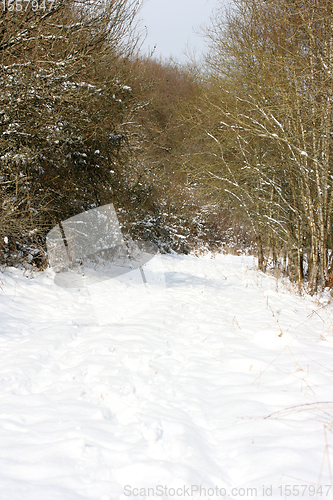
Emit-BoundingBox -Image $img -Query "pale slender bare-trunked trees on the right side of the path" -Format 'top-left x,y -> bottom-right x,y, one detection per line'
185,0 -> 333,291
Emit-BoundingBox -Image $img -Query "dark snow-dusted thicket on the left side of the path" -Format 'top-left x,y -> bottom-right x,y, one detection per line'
0,0 -> 143,259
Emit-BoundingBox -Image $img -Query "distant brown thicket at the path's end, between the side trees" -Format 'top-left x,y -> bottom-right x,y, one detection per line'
118,59 -> 252,253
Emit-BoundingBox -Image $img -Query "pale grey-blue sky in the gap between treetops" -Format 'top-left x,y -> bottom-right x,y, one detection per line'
140,0 -> 223,62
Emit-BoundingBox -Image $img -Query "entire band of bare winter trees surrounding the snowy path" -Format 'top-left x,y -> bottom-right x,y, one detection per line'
0,0 -> 333,293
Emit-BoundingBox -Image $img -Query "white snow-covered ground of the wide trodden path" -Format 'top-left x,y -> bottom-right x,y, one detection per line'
0,255 -> 333,500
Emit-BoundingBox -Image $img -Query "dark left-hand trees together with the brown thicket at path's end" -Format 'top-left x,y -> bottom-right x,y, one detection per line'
0,0 -> 247,265
